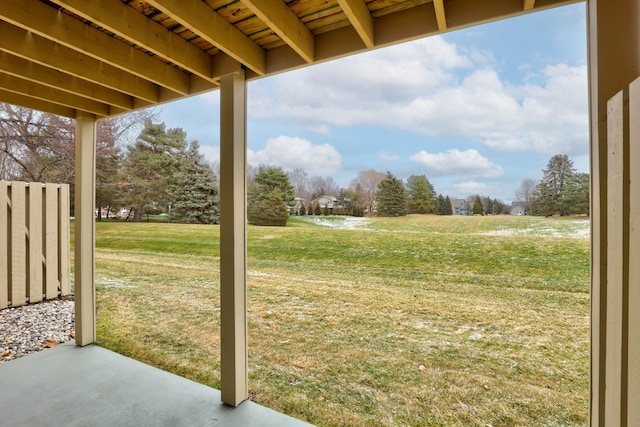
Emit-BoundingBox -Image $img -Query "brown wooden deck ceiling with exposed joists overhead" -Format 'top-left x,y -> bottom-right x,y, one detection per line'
0,0 -> 577,118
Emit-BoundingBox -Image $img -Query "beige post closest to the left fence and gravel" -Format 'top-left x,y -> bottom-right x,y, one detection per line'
74,115 -> 96,346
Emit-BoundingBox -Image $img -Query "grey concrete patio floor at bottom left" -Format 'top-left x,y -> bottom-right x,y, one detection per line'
0,342 -> 310,427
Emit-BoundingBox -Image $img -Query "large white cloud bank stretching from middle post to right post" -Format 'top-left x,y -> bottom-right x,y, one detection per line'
249,36 -> 589,155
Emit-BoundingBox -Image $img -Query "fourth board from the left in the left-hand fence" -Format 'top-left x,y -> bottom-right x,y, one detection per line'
44,184 -> 60,299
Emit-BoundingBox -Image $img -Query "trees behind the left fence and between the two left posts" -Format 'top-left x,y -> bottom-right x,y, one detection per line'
0,104 -> 219,223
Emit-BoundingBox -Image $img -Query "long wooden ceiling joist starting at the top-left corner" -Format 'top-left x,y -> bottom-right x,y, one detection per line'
0,0 -> 190,95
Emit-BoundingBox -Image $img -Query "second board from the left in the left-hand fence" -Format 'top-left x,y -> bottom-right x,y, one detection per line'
9,182 -> 27,307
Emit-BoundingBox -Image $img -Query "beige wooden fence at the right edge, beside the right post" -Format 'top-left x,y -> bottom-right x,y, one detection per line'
591,78 -> 640,427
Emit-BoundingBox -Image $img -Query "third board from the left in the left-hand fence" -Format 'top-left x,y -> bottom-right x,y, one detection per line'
28,183 -> 43,302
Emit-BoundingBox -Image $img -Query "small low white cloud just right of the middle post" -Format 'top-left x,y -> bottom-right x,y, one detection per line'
247,135 -> 342,176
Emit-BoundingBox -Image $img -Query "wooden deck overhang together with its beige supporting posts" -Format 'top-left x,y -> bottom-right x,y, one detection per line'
0,0 -> 640,426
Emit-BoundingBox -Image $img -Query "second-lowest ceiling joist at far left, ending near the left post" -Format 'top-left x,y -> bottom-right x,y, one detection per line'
0,72 -> 109,117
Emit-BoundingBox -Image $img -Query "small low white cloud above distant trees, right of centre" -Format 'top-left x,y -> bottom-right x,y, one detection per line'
409,149 -> 503,178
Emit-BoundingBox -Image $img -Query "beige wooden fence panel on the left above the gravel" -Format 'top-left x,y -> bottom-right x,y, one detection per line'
0,181 -> 71,309
